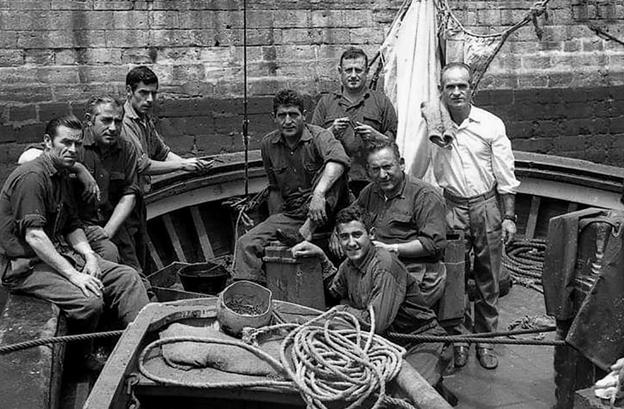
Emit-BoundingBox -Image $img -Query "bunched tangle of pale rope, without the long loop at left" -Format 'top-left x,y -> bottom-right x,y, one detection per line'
280,307 -> 405,409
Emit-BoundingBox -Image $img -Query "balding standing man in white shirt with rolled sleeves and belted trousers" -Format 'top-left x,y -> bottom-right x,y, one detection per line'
432,63 -> 520,369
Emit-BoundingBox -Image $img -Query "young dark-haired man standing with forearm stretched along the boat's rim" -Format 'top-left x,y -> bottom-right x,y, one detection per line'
122,66 -> 212,276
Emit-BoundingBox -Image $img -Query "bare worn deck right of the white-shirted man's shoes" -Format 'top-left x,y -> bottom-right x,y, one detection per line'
444,285 -> 555,409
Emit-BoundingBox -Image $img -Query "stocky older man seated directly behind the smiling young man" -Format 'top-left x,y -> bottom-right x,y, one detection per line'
333,141 -> 446,307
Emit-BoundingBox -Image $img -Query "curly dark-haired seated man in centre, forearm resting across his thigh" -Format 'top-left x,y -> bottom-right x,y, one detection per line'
233,90 -> 349,282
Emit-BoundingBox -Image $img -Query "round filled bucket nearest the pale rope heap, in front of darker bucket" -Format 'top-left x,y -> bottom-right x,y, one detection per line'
217,281 -> 273,337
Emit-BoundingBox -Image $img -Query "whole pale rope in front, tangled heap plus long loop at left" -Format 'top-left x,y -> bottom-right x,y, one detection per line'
139,307 -> 413,409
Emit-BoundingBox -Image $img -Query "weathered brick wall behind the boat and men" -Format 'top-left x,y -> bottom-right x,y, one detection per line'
0,0 -> 624,178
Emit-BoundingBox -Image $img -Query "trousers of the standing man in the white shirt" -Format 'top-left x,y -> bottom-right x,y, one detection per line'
445,193 -> 503,347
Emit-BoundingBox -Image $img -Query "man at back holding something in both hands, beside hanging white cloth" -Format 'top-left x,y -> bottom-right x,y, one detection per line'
312,47 -> 397,197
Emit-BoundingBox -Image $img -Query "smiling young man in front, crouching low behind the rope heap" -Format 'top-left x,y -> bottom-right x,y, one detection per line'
291,206 -> 450,386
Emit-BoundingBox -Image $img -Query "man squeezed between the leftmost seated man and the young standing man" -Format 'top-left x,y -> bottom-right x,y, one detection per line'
79,96 -> 144,290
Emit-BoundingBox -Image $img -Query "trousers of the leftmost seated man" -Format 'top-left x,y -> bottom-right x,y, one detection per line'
3,258 -> 148,332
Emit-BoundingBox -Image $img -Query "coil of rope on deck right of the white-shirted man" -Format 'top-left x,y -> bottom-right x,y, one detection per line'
503,239 -> 546,293
